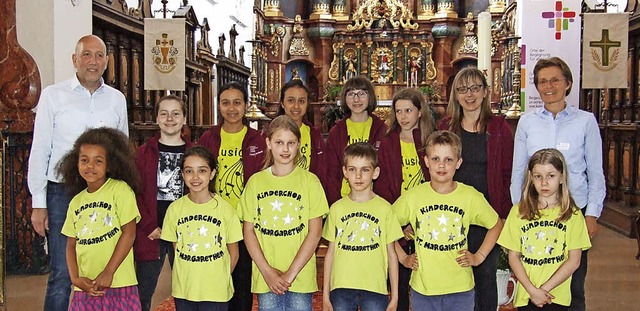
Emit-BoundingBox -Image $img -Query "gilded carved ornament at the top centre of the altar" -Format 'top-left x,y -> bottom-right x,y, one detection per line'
347,0 -> 418,31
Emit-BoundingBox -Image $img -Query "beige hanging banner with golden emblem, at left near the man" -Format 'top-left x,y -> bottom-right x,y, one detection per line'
144,18 -> 186,91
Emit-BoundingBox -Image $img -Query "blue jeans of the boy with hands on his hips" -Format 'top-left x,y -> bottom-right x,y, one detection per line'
411,289 -> 475,311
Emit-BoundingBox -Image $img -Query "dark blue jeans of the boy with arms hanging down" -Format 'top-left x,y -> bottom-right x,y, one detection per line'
329,288 -> 389,311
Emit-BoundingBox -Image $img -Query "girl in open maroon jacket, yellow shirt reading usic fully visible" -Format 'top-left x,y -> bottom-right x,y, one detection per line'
198,82 -> 267,311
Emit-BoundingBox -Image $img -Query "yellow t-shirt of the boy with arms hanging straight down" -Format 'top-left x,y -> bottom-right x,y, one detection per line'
322,196 -> 403,295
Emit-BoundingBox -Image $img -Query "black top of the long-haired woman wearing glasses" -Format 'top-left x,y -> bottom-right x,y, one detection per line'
453,129 -> 489,201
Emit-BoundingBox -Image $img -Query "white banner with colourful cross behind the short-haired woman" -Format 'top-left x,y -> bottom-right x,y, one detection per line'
518,0 -> 582,111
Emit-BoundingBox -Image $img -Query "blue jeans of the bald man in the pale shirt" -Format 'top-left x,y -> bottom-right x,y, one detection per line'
44,182 -> 71,311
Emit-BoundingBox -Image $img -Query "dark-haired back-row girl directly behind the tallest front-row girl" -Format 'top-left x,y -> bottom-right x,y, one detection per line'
278,79 -> 327,185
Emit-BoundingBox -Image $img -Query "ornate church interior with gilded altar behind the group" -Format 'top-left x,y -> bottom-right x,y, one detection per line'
0,0 -> 640,310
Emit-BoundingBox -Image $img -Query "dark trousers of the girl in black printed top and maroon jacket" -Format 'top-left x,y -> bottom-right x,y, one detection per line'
136,240 -> 174,311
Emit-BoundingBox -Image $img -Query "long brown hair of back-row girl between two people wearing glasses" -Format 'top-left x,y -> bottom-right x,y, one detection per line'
387,88 -> 435,146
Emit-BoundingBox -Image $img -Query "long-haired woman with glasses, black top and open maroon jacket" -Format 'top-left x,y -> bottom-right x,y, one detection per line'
438,68 -> 513,311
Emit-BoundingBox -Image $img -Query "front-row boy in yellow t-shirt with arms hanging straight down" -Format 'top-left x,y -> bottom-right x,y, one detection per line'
322,142 -> 403,311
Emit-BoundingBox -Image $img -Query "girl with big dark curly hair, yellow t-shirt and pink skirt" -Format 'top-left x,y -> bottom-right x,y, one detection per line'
57,127 -> 142,311
